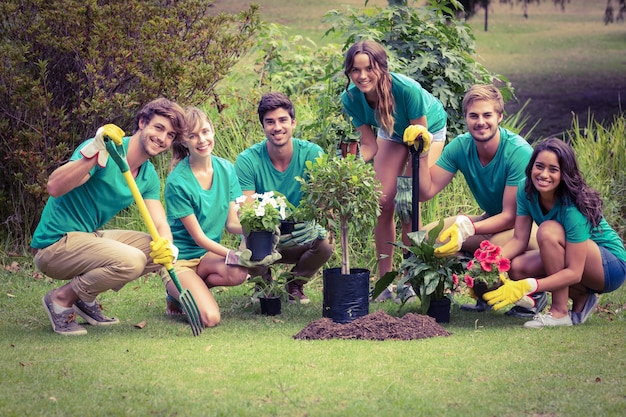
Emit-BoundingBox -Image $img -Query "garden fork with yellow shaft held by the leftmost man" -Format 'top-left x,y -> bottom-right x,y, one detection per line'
104,136 -> 202,336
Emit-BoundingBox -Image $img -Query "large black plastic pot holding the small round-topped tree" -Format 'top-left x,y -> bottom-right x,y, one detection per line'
322,268 -> 370,323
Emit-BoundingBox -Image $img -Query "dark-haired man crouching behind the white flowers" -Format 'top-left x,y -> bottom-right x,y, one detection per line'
235,93 -> 334,304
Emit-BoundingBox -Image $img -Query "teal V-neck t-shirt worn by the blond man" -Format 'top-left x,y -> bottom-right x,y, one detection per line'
437,127 -> 533,216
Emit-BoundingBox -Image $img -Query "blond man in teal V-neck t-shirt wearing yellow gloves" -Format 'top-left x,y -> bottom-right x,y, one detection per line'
419,85 -> 547,317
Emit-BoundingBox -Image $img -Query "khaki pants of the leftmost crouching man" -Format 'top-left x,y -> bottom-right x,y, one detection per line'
35,230 -> 162,302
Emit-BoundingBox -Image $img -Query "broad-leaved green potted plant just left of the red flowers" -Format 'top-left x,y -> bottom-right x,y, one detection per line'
372,220 -> 465,314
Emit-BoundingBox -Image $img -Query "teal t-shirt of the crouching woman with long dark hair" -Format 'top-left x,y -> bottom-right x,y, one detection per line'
517,180 -> 626,261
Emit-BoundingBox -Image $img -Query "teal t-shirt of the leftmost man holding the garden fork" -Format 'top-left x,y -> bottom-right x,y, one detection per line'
31,137 -> 161,249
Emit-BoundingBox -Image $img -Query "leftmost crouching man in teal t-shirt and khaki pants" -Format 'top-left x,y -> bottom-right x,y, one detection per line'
31,99 -> 185,336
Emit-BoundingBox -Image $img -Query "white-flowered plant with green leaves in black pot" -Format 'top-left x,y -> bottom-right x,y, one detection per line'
235,191 -> 288,235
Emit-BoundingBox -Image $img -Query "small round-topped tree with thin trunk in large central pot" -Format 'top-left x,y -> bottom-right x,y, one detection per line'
296,154 -> 381,275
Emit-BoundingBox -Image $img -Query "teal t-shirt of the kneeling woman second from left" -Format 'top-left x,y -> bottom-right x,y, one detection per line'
165,155 -> 242,259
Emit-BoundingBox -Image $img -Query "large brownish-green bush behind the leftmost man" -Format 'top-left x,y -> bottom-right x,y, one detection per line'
0,0 -> 260,242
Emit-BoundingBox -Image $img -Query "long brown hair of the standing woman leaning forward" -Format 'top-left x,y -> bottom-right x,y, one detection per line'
344,40 -> 395,135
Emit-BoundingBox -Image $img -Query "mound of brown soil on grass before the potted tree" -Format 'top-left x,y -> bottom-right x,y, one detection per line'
293,310 -> 450,340
